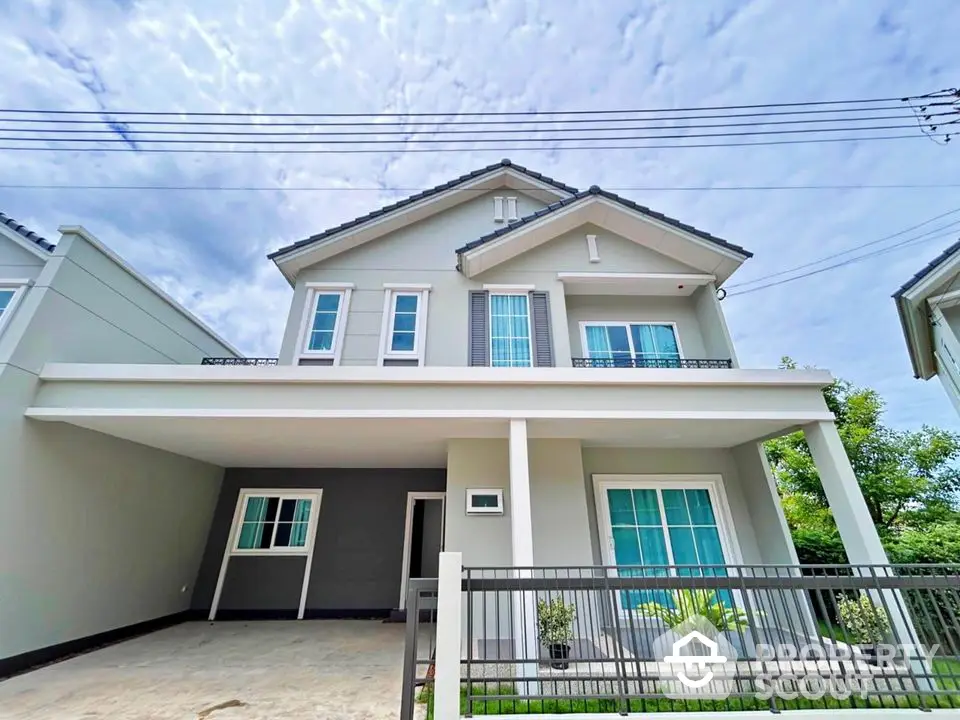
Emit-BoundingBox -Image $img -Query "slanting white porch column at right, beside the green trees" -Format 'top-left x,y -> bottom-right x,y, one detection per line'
803,421 -> 930,688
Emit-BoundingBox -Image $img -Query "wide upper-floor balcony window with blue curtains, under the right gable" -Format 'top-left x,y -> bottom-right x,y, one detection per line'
583,323 -> 682,367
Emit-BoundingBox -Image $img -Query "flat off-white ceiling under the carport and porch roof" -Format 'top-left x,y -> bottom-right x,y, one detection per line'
37,416 -> 791,467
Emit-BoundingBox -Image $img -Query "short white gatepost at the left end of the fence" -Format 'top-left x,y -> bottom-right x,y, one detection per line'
433,552 -> 463,720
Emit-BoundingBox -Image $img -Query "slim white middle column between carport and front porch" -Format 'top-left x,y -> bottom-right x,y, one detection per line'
510,420 -> 540,695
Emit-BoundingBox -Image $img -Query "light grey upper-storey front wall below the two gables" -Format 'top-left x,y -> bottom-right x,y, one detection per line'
280,190 -> 731,367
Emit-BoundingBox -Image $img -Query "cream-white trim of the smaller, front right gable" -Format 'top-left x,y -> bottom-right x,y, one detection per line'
461,195 -> 746,283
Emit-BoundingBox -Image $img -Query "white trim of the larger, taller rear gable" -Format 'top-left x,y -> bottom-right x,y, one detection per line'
274,166 -> 573,285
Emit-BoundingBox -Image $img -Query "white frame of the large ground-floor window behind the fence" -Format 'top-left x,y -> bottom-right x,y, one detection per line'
593,474 -> 743,614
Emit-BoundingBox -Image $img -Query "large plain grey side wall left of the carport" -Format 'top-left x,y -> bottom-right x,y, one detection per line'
0,231 -> 233,658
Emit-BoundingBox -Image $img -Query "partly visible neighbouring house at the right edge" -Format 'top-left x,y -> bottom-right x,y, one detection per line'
893,240 -> 960,412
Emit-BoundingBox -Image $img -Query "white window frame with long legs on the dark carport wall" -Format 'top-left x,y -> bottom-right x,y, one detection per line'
208,488 -> 323,621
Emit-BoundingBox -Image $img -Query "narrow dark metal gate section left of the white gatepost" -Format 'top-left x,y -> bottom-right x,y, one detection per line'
400,578 -> 437,720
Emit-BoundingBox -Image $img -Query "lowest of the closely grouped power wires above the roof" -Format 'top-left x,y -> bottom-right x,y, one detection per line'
0,133 -> 947,155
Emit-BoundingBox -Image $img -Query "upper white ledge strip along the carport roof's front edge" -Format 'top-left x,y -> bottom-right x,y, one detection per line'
33,363 -> 833,388
